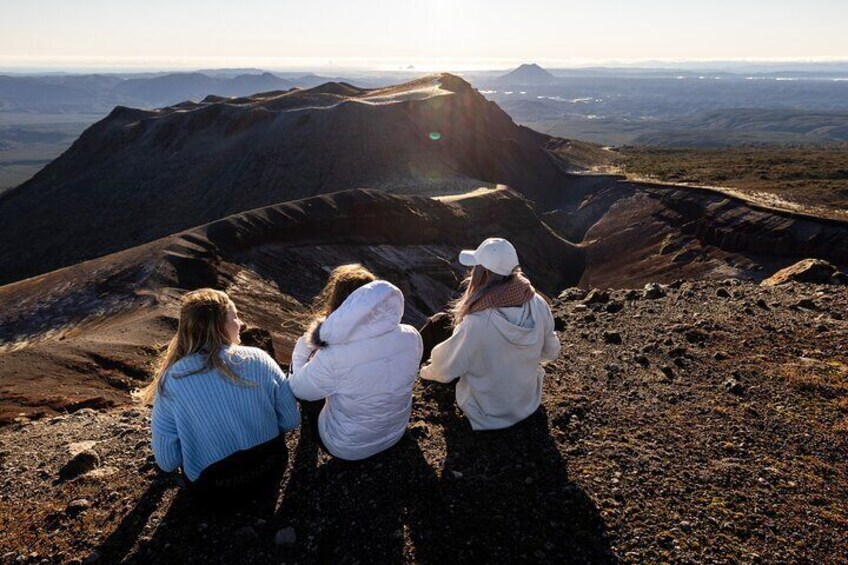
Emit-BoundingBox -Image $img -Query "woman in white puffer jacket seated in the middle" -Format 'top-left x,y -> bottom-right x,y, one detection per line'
289,264 -> 422,460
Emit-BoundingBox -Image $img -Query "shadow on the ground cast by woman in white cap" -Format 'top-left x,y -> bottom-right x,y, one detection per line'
407,376 -> 619,564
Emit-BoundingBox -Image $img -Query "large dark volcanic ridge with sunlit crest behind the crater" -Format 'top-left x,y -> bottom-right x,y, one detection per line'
0,74 -> 565,282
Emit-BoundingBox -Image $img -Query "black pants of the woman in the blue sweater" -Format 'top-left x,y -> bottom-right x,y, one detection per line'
188,434 -> 288,505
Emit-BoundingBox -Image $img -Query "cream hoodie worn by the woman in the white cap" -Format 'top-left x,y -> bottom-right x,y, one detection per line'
421,294 -> 560,430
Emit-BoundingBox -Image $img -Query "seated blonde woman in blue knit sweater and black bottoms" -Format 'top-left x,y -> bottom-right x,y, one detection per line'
142,288 -> 300,498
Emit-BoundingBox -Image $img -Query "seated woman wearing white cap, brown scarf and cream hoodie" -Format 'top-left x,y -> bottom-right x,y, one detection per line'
421,238 -> 560,430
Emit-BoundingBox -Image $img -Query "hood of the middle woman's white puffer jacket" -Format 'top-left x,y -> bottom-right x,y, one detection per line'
320,281 -> 403,345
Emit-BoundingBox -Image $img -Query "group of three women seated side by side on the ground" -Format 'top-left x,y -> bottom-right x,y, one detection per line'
143,238 -> 560,498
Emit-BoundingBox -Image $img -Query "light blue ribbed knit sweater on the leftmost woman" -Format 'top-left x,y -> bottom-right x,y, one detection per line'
151,346 -> 300,481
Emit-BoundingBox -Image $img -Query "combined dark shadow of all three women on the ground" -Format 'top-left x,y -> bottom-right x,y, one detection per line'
99,384 -> 617,564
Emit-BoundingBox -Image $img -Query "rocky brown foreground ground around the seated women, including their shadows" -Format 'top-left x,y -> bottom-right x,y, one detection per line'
0,280 -> 848,563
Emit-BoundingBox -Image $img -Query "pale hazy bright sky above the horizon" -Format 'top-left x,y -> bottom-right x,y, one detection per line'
0,0 -> 848,70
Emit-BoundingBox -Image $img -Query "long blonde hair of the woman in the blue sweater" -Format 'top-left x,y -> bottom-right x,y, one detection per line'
140,288 -> 249,404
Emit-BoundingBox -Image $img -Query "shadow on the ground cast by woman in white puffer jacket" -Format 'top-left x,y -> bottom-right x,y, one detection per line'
275,404 -> 438,563
